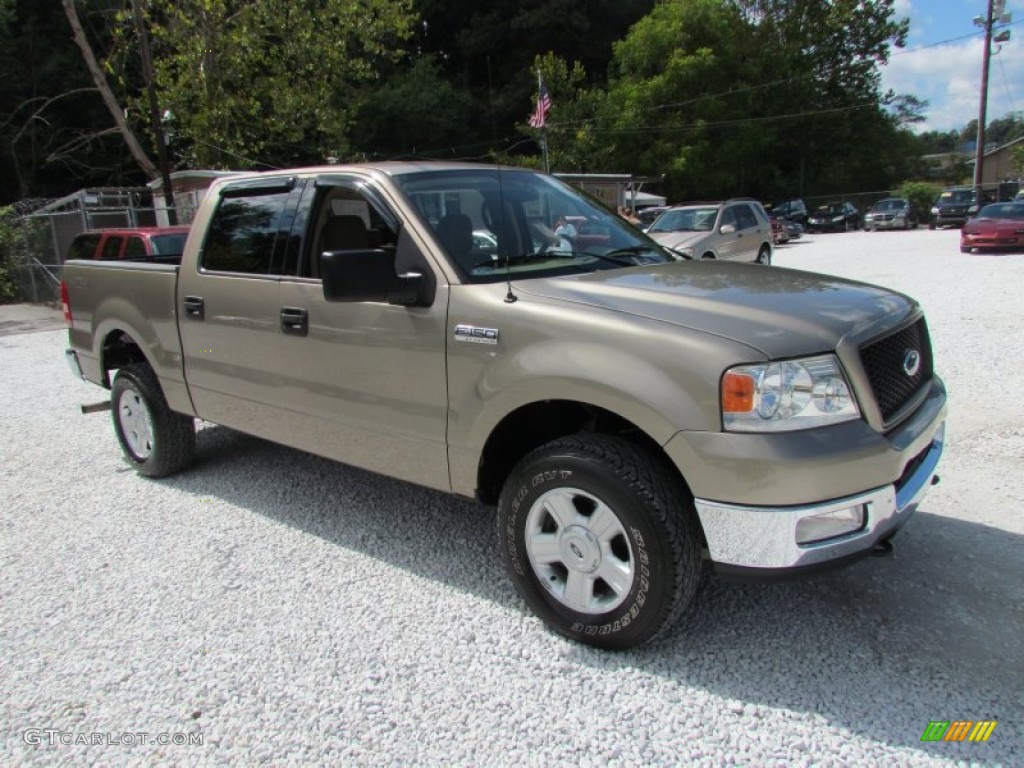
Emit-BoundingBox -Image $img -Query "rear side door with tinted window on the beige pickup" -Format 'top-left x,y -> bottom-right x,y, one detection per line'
177,177 -> 301,439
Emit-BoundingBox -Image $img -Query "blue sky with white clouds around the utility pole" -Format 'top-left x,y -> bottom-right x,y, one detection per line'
882,0 -> 1024,132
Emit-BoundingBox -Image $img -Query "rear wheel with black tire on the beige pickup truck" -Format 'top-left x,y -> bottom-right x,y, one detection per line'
111,364 -> 196,477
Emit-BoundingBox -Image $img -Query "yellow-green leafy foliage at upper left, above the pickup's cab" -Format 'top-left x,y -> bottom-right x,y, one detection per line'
136,0 -> 413,168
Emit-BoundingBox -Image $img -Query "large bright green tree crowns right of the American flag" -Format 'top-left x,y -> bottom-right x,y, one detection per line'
532,0 -> 909,200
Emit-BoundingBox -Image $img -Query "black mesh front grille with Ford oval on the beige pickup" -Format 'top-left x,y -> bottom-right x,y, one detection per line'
860,317 -> 932,425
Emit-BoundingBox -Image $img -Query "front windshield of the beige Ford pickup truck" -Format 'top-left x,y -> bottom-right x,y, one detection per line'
394,167 -> 675,283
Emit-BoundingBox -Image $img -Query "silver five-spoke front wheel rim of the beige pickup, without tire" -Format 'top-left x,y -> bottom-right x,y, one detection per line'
525,487 -> 636,613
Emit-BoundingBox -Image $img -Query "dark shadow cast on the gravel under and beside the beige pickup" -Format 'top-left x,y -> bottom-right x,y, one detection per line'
161,427 -> 1024,764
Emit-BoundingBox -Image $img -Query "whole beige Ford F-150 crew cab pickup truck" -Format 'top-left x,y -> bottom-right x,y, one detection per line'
62,163 -> 946,648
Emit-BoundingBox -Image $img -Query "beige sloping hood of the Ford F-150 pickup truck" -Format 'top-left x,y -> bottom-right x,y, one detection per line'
516,261 -> 918,358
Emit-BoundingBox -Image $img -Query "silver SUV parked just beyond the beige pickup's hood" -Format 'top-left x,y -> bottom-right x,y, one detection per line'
647,198 -> 771,264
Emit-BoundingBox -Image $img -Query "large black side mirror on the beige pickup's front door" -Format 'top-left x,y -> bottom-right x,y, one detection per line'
319,249 -> 433,306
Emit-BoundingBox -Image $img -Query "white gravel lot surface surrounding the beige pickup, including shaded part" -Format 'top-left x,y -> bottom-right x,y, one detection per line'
0,229 -> 1024,766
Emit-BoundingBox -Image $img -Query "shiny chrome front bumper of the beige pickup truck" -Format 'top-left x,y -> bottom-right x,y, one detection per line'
694,424 -> 945,572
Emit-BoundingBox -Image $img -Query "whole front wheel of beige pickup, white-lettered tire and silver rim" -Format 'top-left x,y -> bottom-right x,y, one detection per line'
498,435 -> 703,649
